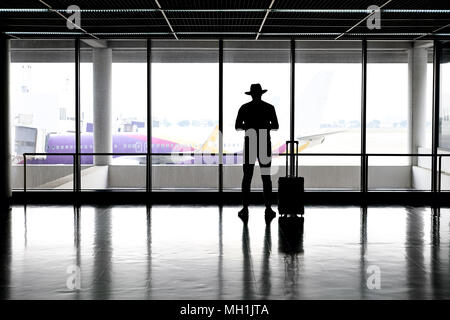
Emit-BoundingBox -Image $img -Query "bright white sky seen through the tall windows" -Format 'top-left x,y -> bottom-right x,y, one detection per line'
11,63 -> 440,145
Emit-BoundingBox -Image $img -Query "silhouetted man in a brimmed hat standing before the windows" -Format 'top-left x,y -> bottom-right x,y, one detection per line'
235,83 -> 279,221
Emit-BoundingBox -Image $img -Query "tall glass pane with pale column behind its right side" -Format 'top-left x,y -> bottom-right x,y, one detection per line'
367,41 -> 433,191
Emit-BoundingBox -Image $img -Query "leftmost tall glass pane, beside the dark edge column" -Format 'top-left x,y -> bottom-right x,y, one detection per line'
10,40 -> 75,189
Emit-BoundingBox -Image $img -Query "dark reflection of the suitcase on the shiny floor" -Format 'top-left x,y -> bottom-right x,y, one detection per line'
278,211 -> 304,299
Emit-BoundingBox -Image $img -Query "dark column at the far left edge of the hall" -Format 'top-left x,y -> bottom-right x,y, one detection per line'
0,36 -> 11,203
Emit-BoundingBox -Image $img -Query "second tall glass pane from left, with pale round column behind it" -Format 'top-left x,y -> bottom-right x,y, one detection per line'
80,40 -> 147,190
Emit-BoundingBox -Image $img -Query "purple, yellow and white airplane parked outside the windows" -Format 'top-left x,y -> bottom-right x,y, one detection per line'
19,126 -> 342,165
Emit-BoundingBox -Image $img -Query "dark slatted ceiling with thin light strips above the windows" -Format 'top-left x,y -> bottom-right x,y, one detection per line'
0,0 -> 450,40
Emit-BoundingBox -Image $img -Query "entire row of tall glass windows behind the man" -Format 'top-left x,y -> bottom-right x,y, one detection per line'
10,40 -> 442,191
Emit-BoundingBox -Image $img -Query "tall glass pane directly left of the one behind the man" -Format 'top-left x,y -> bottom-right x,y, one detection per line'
151,41 -> 219,191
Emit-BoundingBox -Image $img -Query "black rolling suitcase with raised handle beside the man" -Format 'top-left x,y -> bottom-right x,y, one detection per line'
278,141 -> 305,216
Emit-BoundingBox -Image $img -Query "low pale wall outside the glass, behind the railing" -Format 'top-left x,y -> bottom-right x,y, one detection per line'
12,165 -> 428,190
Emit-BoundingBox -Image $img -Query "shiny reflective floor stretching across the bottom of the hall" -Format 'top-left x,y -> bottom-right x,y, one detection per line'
0,206 -> 450,299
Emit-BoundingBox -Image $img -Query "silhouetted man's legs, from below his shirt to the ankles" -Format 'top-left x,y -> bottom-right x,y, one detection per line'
242,135 -> 272,208
